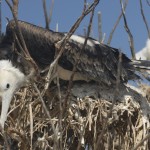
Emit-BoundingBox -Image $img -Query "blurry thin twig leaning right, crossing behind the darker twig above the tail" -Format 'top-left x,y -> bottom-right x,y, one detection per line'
107,0 -> 128,45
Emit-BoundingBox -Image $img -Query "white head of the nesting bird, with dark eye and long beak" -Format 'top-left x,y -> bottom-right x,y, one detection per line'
0,60 -> 25,128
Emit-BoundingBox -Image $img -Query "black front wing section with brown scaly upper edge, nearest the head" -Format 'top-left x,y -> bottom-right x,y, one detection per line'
4,20 -> 64,68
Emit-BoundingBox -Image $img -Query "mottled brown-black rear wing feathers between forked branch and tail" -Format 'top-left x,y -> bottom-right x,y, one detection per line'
60,36 -> 138,84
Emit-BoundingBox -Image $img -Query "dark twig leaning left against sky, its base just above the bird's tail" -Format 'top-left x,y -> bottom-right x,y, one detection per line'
120,0 -> 136,59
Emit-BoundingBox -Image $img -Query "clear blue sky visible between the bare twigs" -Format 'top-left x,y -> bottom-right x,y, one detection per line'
2,0 -> 150,57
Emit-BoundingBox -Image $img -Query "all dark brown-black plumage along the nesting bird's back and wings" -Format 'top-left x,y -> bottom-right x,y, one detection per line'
2,21 -> 138,84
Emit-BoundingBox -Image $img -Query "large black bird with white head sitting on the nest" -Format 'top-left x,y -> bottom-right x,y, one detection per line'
0,20 -> 149,128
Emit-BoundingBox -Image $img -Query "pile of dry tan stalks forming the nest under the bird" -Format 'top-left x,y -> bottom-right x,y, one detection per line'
0,83 -> 150,150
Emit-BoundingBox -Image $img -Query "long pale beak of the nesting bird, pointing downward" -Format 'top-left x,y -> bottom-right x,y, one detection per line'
0,92 -> 13,128
